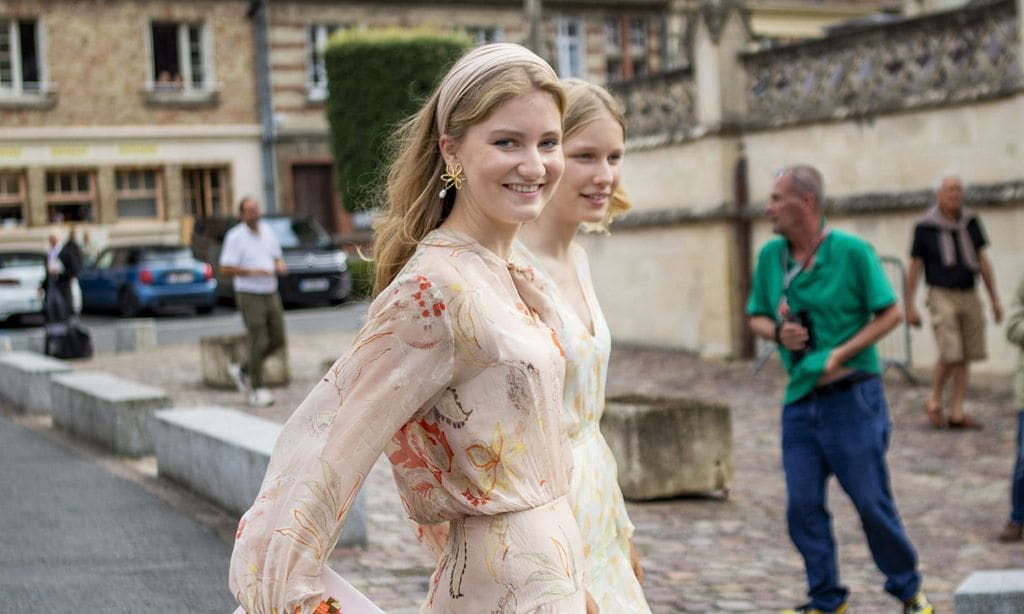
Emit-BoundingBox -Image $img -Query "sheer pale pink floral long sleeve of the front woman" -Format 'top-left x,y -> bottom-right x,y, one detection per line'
234,275 -> 455,614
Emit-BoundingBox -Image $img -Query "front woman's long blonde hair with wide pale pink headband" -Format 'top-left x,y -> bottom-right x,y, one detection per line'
374,44 -> 566,296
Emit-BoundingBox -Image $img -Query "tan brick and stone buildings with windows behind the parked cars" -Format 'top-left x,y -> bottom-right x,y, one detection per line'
0,0 -> 877,247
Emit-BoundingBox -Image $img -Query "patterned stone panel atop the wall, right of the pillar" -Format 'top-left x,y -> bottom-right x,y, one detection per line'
741,0 -> 1022,127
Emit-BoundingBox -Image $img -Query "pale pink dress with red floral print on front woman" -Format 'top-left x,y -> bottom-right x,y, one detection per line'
229,229 -> 585,614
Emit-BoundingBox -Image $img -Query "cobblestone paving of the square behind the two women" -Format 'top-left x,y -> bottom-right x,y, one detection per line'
76,333 -> 1024,614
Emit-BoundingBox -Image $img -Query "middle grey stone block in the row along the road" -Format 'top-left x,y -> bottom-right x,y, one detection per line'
50,371 -> 171,456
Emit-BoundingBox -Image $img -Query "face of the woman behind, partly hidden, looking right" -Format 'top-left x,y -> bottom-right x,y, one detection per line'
546,112 -> 626,224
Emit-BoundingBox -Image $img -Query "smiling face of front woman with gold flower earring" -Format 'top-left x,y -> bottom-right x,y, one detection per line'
440,90 -> 564,231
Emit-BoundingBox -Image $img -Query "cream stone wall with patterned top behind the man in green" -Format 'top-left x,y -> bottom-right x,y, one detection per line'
585,0 -> 1024,371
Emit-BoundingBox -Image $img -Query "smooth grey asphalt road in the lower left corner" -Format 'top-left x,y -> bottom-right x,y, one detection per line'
0,413 -> 233,614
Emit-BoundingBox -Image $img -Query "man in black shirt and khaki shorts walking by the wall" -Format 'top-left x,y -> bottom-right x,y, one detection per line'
906,177 -> 1002,429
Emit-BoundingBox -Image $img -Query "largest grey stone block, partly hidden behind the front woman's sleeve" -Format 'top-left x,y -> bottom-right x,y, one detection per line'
153,407 -> 367,546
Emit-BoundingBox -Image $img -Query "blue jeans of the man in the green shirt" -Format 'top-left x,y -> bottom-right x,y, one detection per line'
782,378 -> 921,612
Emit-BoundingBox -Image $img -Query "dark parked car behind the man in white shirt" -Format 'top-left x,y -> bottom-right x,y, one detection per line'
191,215 -> 352,305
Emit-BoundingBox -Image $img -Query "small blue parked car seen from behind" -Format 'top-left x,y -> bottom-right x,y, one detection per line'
78,245 -> 217,317
